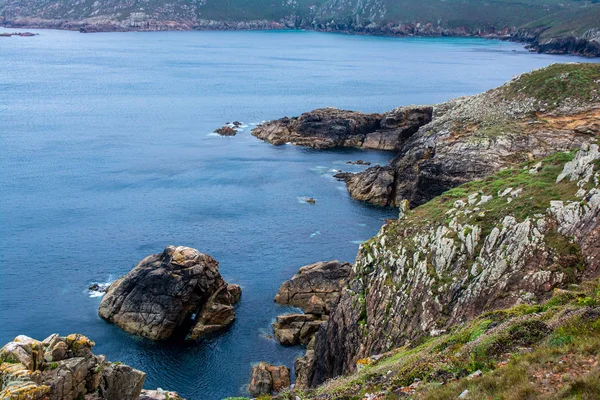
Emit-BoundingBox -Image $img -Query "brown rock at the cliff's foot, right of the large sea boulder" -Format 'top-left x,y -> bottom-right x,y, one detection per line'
275,260 -> 352,315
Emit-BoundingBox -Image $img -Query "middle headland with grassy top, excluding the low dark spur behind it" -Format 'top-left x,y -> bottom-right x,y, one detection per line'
339,64 -> 600,207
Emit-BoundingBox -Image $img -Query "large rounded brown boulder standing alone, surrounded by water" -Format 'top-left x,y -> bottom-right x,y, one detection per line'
98,246 -> 241,340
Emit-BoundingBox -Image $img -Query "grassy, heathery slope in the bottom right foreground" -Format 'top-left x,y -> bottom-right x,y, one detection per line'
308,281 -> 600,400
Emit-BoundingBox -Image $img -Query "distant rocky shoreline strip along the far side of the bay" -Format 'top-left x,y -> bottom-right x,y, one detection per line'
0,12 -> 600,57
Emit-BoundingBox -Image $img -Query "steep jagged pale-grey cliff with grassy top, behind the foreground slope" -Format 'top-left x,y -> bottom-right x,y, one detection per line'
297,144 -> 600,387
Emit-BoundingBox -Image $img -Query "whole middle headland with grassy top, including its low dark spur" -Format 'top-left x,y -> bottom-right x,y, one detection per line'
252,64 -> 600,207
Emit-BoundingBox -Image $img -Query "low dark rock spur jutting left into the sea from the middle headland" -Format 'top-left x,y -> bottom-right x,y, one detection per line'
252,107 -> 432,150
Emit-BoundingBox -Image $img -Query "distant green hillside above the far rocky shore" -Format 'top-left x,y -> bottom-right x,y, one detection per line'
0,0 -> 597,28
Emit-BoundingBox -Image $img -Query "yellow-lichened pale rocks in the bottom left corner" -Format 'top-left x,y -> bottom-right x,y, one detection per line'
0,334 -> 168,400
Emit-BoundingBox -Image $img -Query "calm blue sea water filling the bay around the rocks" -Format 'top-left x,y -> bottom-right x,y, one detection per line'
0,28 -> 596,399
